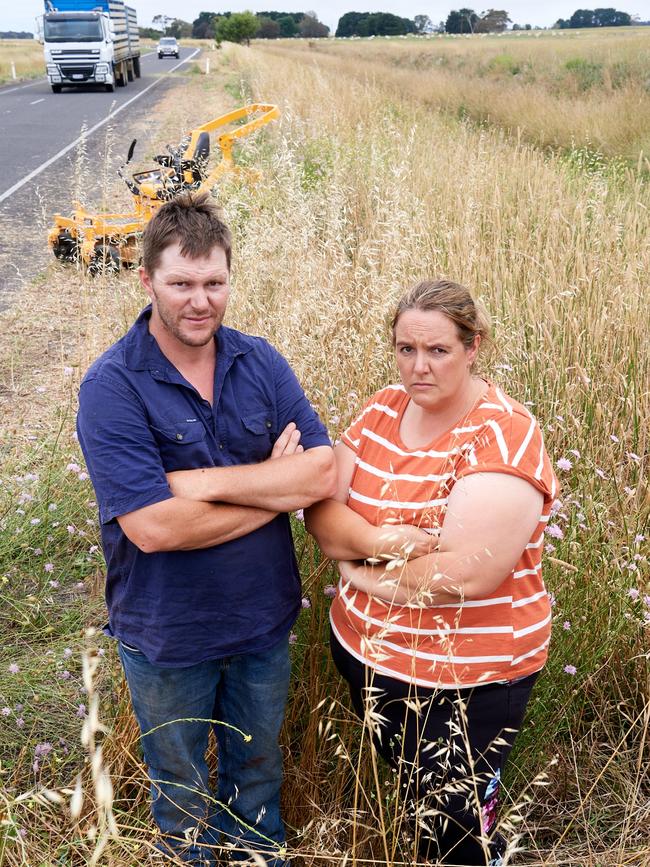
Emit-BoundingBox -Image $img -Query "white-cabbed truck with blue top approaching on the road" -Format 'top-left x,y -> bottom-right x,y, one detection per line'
40,0 -> 140,93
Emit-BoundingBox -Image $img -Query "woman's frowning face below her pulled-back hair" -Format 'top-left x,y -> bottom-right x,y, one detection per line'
395,310 -> 481,411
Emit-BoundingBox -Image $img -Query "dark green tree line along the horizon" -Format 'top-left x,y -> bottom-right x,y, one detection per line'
140,8 -> 634,42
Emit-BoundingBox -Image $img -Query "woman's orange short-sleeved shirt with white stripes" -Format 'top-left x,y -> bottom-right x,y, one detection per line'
330,384 -> 557,688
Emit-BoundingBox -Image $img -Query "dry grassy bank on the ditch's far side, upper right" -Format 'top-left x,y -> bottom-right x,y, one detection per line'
260,28 -> 650,168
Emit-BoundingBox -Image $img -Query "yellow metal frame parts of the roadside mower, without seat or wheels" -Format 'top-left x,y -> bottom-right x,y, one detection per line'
47,102 -> 280,266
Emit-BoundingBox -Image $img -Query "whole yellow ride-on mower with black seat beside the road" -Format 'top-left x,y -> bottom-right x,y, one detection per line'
48,103 -> 280,274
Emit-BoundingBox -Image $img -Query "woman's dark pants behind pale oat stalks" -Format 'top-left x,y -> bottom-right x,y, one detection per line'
331,635 -> 537,867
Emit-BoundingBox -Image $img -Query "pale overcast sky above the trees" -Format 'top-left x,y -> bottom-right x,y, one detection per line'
5,0 -> 650,33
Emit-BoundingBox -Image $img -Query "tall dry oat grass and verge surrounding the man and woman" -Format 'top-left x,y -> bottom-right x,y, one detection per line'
0,47 -> 650,867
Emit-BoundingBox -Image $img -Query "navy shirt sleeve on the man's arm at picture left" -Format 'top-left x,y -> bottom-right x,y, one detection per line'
77,376 -> 172,524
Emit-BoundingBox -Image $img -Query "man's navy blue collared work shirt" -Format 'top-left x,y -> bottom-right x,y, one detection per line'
77,306 -> 330,668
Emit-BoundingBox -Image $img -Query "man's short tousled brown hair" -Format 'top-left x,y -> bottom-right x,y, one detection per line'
142,193 -> 232,275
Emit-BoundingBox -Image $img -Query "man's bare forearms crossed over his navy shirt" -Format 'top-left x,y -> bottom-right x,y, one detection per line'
117,423 -> 336,554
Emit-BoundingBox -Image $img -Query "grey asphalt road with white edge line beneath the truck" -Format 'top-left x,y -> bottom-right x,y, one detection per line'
0,48 -> 198,309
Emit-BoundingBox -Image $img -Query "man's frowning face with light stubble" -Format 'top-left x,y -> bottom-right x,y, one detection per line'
140,243 -> 230,346
